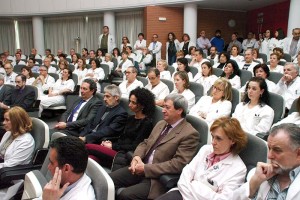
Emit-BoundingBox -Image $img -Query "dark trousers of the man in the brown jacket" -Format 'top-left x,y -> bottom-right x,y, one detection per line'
109,167 -> 151,200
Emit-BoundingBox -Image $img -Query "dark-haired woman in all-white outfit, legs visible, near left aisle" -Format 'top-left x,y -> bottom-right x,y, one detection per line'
39,69 -> 75,116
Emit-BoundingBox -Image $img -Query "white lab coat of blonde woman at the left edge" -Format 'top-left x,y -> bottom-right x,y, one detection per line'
0,131 -> 35,169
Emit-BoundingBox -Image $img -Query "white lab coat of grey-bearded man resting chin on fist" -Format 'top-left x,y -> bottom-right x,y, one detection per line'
230,168 -> 300,200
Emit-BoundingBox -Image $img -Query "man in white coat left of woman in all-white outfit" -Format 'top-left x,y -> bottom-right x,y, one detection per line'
32,65 -> 55,99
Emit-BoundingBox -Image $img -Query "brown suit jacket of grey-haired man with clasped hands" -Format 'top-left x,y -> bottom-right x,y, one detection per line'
134,119 -> 200,199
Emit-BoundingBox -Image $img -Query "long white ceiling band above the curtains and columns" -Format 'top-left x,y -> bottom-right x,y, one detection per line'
0,0 -> 195,16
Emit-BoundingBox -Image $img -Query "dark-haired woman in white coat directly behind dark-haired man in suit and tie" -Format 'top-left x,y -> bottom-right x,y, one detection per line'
85,59 -> 105,93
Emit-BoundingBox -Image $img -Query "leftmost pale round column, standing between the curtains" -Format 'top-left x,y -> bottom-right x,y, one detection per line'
32,17 -> 45,55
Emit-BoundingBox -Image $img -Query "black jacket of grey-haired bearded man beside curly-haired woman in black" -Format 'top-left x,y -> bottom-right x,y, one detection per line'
80,104 -> 128,144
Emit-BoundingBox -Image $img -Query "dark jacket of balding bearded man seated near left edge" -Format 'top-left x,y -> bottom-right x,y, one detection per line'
4,86 -> 35,111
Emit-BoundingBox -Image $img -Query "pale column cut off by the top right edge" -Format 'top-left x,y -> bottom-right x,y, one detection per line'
287,0 -> 300,37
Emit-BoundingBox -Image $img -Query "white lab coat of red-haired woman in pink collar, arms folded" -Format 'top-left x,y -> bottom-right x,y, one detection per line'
177,145 -> 247,200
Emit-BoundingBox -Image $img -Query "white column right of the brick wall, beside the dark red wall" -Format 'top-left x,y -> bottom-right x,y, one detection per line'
183,3 -> 197,44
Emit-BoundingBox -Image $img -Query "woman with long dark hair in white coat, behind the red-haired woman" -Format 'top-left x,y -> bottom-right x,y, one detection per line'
232,77 -> 274,135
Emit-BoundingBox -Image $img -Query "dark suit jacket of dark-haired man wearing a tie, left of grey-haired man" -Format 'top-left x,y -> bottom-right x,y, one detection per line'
59,95 -> 102,137
